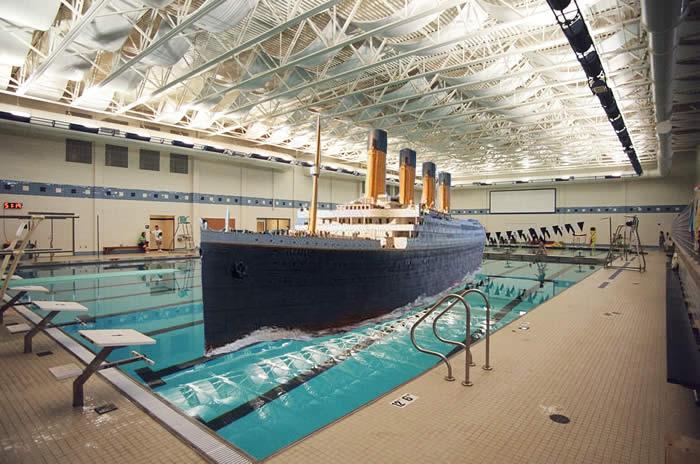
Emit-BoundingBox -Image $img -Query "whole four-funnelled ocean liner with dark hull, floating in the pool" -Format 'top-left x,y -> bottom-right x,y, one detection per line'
201,124 -> 485,349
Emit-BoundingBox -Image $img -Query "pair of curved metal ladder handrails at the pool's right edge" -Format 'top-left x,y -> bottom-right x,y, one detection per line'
411,288 -> 493,387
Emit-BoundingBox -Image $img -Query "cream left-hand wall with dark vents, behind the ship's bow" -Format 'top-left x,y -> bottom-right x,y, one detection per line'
0,128 -> 361,252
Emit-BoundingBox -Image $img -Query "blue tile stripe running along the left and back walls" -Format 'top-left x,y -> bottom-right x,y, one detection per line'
0,179 -> 687,216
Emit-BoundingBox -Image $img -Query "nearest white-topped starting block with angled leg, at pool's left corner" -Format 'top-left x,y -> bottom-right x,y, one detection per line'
73,329 -> 156,407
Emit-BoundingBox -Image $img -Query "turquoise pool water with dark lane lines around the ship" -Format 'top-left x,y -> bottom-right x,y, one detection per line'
9,260 -> 597,459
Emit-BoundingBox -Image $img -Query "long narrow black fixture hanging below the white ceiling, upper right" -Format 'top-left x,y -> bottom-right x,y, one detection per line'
547,0 -> 643,175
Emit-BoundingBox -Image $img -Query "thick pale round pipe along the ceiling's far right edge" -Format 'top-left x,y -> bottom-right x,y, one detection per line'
641,0 -> 688,176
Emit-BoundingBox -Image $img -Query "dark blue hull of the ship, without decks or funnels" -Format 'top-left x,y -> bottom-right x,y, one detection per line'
202,241 -> 483,348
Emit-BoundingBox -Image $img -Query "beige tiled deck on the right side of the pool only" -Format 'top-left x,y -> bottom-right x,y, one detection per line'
269,252 -> 700,464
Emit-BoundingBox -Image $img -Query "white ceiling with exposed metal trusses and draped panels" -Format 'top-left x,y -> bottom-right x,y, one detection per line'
0,0 -> 700,180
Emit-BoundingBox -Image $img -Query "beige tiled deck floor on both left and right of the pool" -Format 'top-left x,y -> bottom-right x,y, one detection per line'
0,252 -> 700,464
